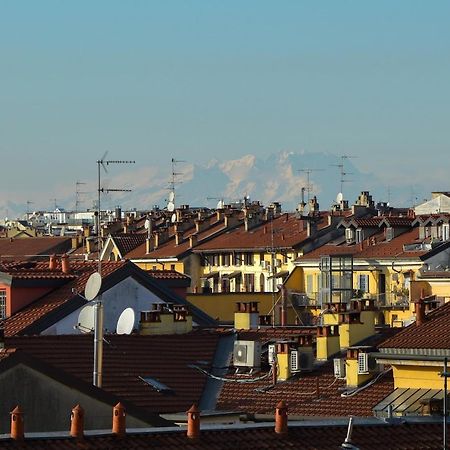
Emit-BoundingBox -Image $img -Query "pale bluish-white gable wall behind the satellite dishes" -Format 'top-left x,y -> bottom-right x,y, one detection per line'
41,277 -> 164,334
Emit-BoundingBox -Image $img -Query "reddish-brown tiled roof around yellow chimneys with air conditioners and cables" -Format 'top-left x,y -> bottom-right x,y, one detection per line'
217,361 -> 394,417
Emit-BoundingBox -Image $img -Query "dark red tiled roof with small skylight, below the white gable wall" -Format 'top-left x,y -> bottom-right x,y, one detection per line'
6,331 -> 218,413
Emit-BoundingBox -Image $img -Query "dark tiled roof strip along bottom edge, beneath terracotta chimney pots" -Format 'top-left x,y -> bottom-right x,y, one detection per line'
0,420 -> 442,450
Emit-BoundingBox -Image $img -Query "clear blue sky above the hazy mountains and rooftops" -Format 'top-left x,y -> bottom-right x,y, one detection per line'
0,0 -> 450,207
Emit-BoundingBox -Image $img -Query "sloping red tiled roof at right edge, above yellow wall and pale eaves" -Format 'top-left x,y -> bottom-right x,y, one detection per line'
379,303 -> 450,349
